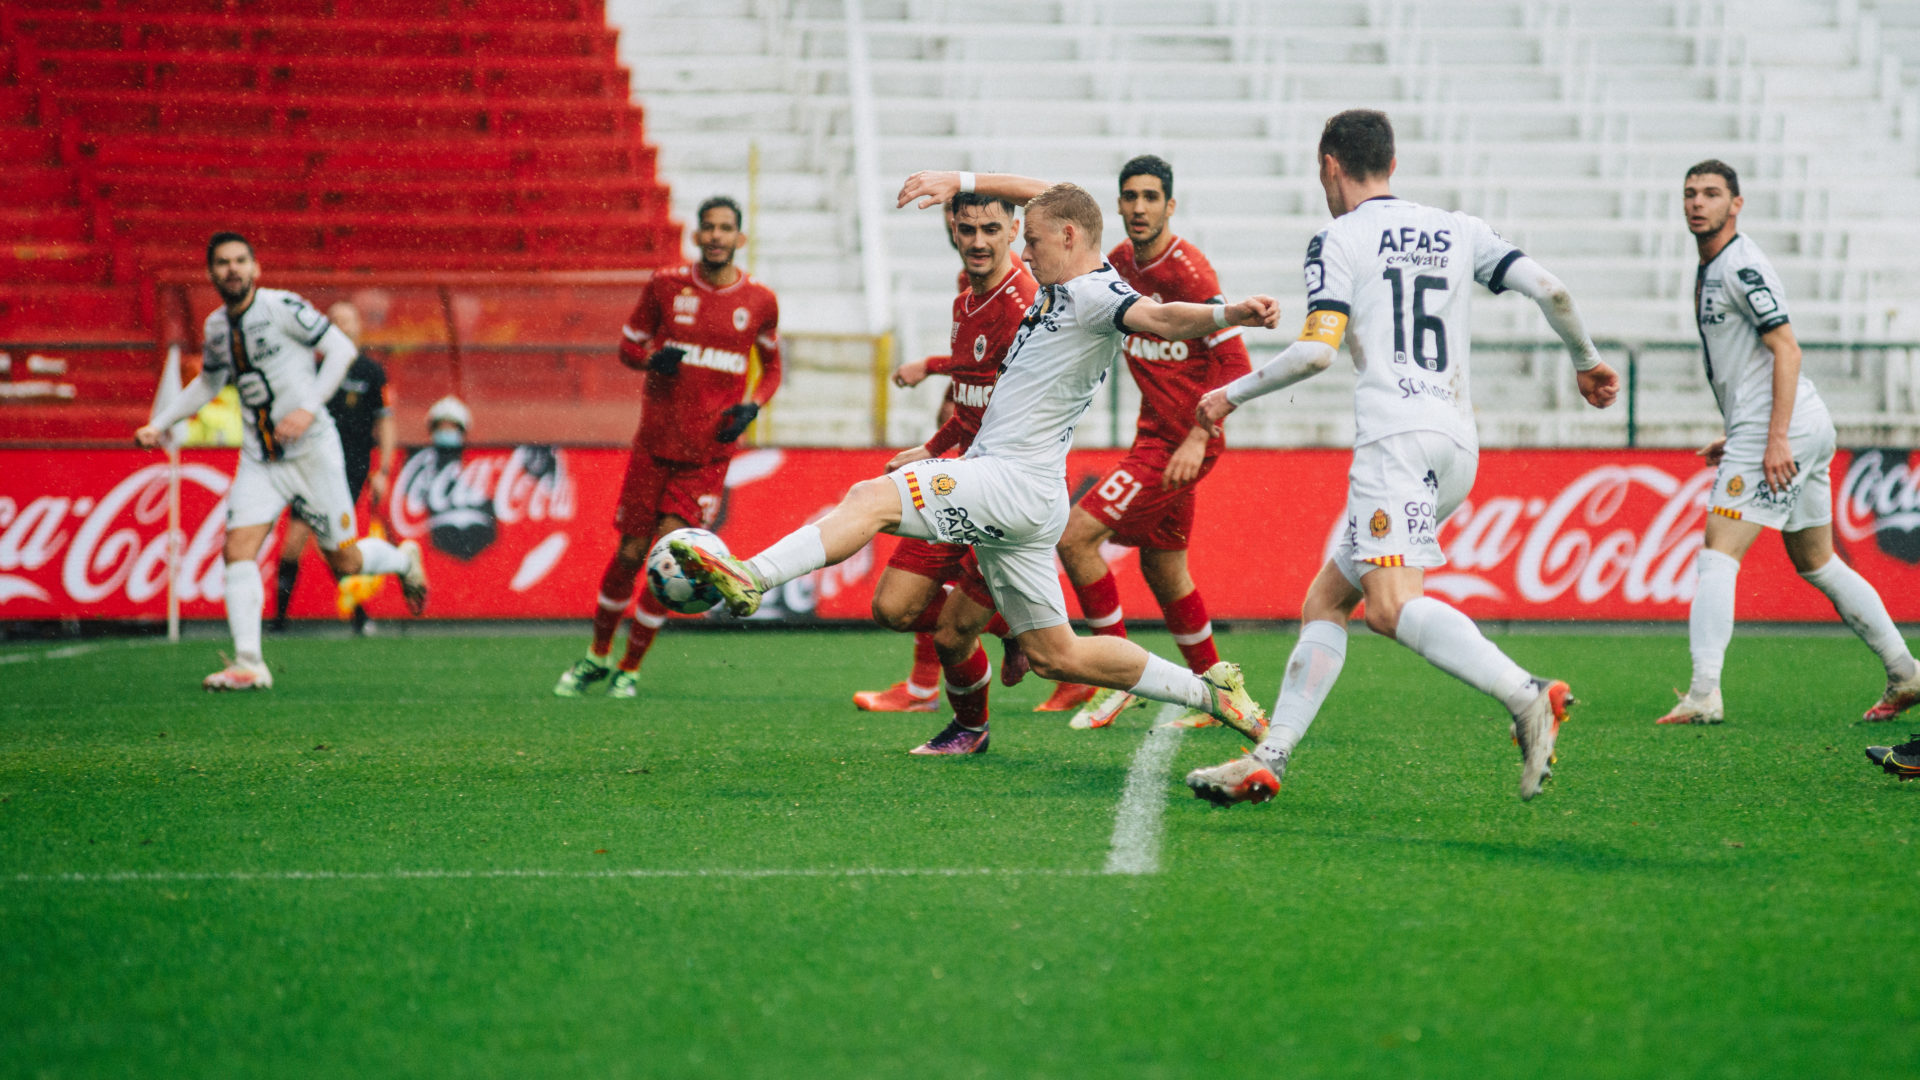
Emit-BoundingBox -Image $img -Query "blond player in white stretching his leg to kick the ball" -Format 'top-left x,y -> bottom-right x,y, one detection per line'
672,173 -> 1279,753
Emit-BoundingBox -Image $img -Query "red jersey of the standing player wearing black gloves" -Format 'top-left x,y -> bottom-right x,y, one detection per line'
620,265 -> 780,463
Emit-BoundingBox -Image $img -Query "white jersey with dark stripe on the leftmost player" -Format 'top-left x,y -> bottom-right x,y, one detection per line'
202,288 -> 334,461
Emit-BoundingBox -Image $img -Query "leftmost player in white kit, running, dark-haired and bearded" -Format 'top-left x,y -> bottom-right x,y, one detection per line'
132,233 -> 426,690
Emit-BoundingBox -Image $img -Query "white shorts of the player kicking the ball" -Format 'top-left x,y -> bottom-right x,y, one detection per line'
889,457 -> 1071,634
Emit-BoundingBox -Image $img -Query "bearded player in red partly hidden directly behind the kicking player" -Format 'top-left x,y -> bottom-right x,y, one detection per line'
852,192 -> 1039,713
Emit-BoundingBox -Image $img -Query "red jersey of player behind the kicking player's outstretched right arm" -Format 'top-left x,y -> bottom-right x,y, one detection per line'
1106,236 -> 1252,454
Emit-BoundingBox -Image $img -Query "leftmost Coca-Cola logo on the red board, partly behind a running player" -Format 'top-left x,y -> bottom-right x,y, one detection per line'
0,465 -> 247,605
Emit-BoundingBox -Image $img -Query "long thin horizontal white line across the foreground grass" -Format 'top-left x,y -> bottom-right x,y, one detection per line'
0,867 -> 1098,884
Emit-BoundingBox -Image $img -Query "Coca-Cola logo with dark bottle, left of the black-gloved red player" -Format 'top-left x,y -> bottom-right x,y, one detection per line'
390,446 -> 574,559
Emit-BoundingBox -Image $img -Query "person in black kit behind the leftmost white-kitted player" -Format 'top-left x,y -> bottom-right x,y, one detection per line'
269,300 -> 399,634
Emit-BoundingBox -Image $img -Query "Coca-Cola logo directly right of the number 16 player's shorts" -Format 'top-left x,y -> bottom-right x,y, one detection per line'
1327,465 -> 1713,603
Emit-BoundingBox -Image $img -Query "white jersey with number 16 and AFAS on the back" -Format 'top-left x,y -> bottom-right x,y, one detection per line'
1306,196 -> 1521,450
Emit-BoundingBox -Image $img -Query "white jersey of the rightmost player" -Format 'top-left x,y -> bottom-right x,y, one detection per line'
1693,234 -> 1826,452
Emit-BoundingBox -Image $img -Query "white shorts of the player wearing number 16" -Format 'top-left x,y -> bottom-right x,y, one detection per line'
1332,430 -> 1480,588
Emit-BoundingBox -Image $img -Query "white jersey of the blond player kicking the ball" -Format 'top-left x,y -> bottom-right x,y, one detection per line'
966,263 -> 1140,480
